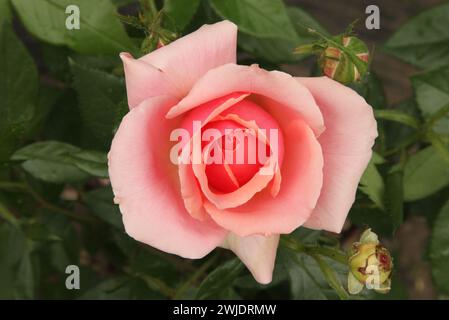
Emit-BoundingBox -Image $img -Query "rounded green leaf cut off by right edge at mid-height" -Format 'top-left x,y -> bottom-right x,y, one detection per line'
404,147 -> 449,201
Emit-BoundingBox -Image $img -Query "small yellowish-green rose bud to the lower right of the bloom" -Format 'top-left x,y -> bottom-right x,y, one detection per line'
348,229 -> 393,294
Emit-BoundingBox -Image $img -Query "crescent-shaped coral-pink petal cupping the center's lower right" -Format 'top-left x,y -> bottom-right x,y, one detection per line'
204,119 -> 323,236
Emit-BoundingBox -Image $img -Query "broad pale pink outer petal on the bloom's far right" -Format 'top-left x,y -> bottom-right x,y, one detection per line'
297,77 -> 377,233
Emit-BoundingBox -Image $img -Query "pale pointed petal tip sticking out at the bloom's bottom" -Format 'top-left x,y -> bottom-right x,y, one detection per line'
222,233 -> 279,284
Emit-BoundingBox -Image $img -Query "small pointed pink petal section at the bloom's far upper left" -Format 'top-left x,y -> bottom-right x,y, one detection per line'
120,52 -> 182,109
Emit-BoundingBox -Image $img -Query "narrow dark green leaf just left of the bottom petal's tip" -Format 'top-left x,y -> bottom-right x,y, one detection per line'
196,258 -> 243,300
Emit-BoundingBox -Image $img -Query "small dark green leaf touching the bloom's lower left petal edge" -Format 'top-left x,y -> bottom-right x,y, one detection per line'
83,187 -> 123,230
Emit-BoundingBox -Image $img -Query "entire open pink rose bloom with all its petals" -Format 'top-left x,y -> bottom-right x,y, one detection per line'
109,21 -> 377,284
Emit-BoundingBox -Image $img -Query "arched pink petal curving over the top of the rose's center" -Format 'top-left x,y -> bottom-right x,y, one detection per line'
167,64 -> 324,135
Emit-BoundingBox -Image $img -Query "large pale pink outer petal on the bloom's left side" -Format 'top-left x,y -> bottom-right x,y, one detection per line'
109,97 -> 227,258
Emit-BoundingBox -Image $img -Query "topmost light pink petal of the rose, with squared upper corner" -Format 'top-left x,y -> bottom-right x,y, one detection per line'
141,21 -> 237,97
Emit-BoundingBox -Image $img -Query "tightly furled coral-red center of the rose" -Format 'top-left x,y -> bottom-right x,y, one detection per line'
202,100 -> 283,193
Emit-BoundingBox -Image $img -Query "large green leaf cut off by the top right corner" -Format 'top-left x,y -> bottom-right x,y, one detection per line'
384,4 -> 449,69
